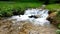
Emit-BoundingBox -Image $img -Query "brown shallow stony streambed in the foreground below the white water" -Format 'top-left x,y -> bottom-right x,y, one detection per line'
0,20 -> 57,34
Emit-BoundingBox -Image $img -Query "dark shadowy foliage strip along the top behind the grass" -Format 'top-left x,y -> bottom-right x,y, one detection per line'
0,0 -> 60,4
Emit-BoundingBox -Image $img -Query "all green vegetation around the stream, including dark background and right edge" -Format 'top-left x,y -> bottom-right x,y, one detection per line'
0,0 -> 60,34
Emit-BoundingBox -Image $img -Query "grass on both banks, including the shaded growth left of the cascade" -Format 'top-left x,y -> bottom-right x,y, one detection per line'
0,1 -> 60,16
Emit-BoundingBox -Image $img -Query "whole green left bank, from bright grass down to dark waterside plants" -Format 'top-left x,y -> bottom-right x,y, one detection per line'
0,2 -> 42,17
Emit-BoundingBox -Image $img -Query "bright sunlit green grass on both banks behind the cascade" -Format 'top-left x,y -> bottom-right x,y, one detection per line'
0,2 -> 60,10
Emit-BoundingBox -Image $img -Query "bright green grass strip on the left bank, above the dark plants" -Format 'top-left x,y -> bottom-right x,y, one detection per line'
0,2 -> 42,9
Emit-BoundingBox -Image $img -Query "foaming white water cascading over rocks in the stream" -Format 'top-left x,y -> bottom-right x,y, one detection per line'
11,9 -> 50,26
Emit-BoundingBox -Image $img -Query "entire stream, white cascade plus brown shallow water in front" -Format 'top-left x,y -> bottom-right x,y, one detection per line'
0,9 -> 57,34
